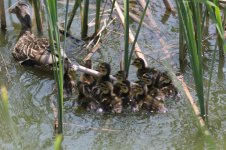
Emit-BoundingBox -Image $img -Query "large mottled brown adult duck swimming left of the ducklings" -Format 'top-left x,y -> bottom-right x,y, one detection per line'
9,2 -> 71,67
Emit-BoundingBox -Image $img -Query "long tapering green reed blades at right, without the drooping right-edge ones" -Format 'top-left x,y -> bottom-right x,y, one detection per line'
176,0 -> 205,118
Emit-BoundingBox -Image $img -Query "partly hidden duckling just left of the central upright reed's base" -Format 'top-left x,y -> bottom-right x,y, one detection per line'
113,70 -> 126,95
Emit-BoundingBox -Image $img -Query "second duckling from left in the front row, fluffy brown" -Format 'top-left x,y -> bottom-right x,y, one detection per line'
100,81 -> 122,113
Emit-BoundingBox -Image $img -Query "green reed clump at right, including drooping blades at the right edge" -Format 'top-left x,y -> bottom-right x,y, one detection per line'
176,0 -> 223,118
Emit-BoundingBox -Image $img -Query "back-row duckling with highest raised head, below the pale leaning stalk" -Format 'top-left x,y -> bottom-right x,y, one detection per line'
132,58 -> 159,79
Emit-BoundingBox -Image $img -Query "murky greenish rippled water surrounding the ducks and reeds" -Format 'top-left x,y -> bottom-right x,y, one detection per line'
0,0 -> 226,150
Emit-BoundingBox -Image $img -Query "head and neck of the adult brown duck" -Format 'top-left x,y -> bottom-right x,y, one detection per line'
8,1 -> 31,32
